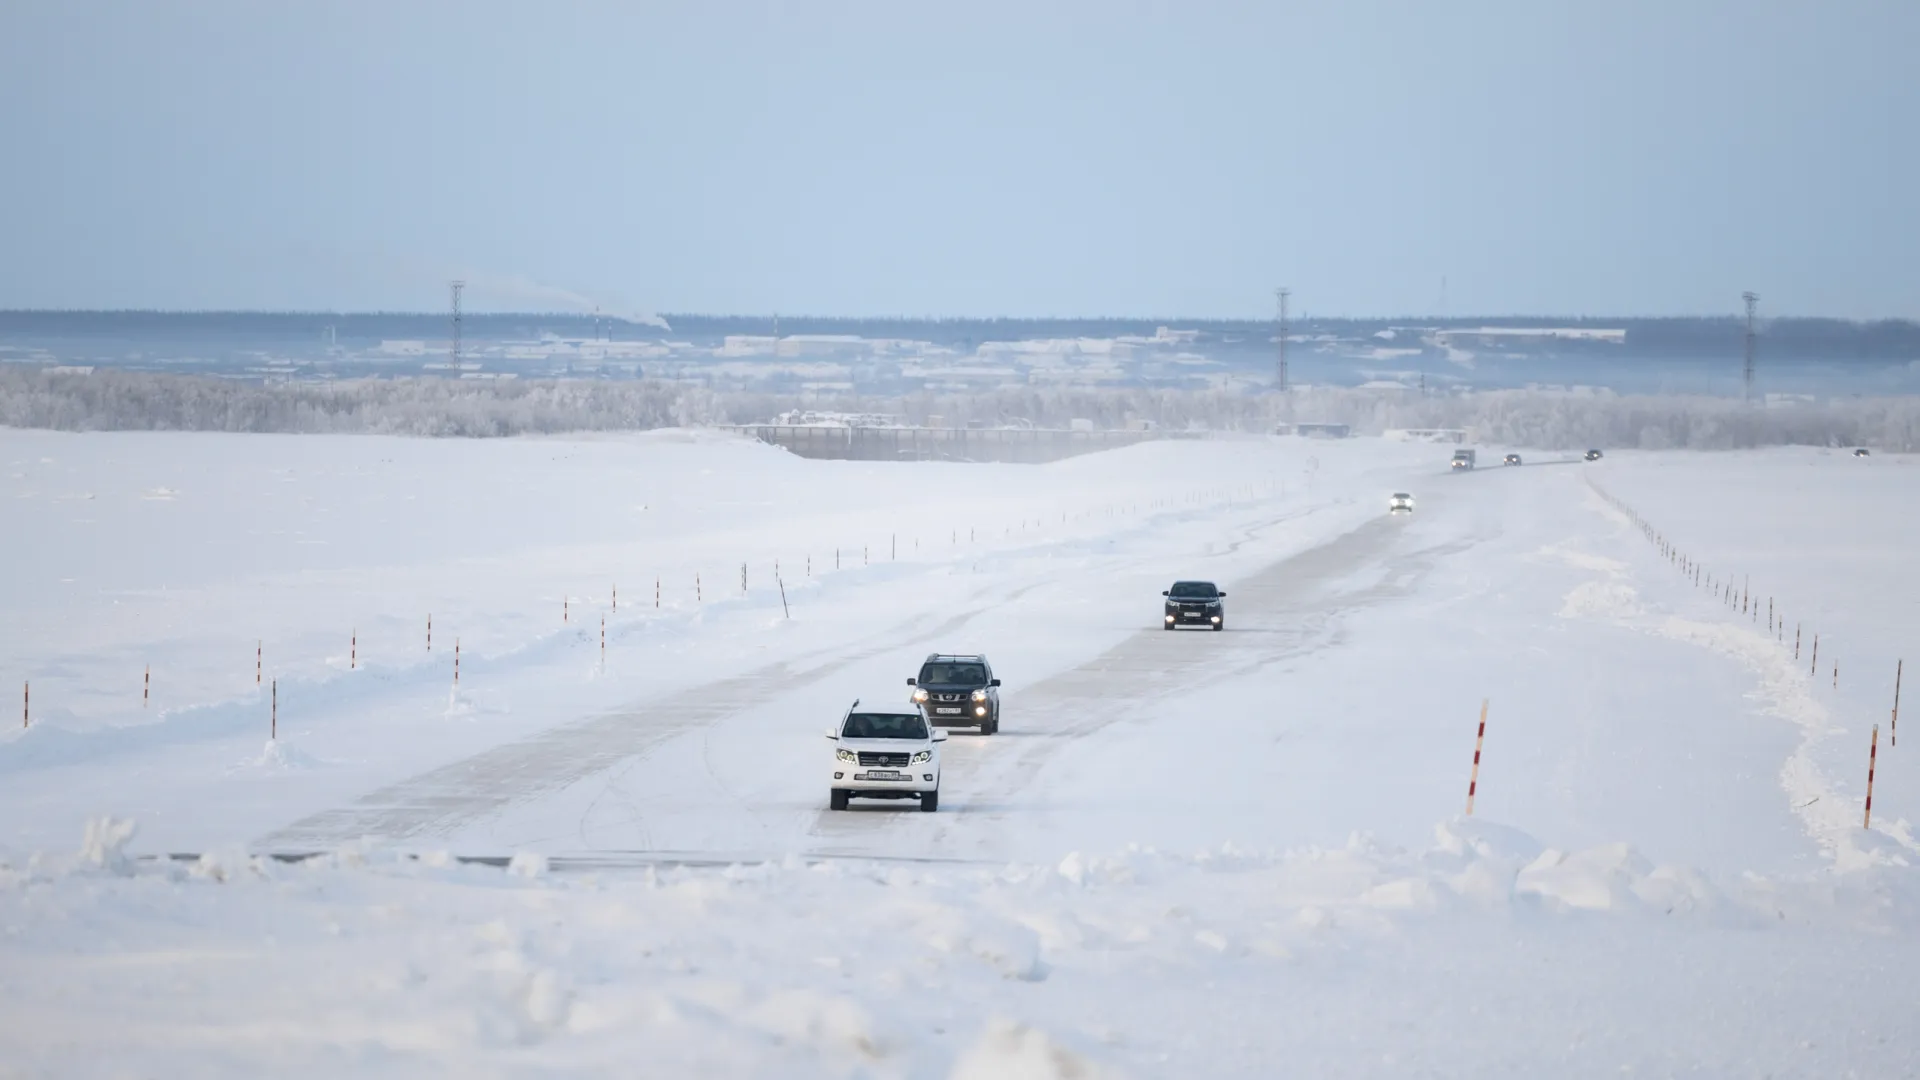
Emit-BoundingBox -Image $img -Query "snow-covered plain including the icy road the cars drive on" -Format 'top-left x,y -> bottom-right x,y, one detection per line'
0,430 -> 1920,1078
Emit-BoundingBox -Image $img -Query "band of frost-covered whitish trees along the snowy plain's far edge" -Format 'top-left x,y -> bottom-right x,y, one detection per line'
0,365 -> 1920,452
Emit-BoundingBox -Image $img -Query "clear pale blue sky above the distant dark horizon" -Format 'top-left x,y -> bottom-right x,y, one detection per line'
0,0 -> 1920,317
